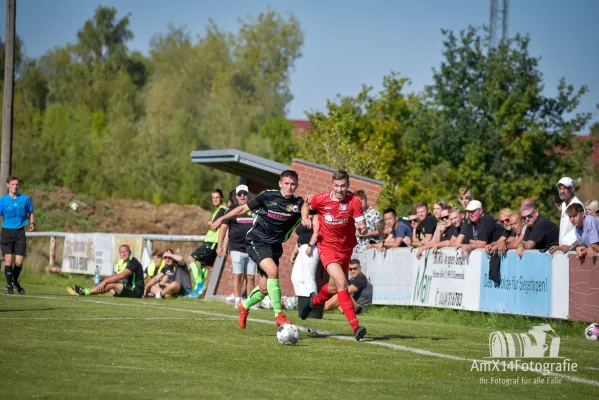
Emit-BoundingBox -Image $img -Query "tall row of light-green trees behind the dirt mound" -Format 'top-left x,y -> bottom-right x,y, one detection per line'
0,6 -> 303,209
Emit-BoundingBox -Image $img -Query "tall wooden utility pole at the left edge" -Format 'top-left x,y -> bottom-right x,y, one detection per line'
0,0 -> 17,195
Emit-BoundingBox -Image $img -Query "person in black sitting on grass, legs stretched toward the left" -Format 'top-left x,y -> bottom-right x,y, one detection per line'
67,244 -> 144,298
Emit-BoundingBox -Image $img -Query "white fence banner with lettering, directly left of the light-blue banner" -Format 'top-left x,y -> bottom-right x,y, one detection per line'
412,248 -> 482,311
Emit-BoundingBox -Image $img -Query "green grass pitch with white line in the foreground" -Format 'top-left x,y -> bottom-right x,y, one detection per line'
0,280 -> 599,399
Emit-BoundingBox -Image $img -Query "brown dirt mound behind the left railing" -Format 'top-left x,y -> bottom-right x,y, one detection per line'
26,187 -> 212,235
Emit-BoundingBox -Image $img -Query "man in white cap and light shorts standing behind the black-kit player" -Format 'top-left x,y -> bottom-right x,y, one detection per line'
216,185 -> 256,308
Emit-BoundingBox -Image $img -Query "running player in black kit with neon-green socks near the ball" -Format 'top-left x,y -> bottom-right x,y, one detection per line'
212,170 -> 304,329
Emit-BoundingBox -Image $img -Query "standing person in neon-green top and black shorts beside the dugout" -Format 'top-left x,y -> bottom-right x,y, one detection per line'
187,189 -> 227,297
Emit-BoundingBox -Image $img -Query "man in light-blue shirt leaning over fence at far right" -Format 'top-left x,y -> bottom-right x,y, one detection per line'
549,203 -> 599,257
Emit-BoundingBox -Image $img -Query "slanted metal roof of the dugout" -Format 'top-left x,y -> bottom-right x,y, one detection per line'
191,149 -> 291,187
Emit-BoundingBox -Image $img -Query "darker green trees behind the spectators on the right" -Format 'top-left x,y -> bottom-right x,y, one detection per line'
308,28 -> 591,214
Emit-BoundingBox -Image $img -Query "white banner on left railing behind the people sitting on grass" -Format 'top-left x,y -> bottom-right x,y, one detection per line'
62,233 -> 113,276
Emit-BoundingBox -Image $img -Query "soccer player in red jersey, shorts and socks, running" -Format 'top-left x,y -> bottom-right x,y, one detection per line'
300,171 -> 367,341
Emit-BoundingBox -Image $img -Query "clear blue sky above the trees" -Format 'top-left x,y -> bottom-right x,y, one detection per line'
0,0 -> 599,130
